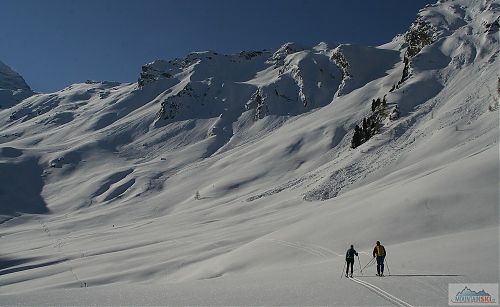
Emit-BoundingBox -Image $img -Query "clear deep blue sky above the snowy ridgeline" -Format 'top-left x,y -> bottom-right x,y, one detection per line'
0,0 -> 435,92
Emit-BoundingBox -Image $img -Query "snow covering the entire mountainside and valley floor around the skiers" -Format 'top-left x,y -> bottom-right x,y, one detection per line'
0,1 -> 500,305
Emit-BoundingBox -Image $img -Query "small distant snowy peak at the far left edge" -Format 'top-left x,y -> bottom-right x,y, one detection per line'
0,61 -> 33,108
